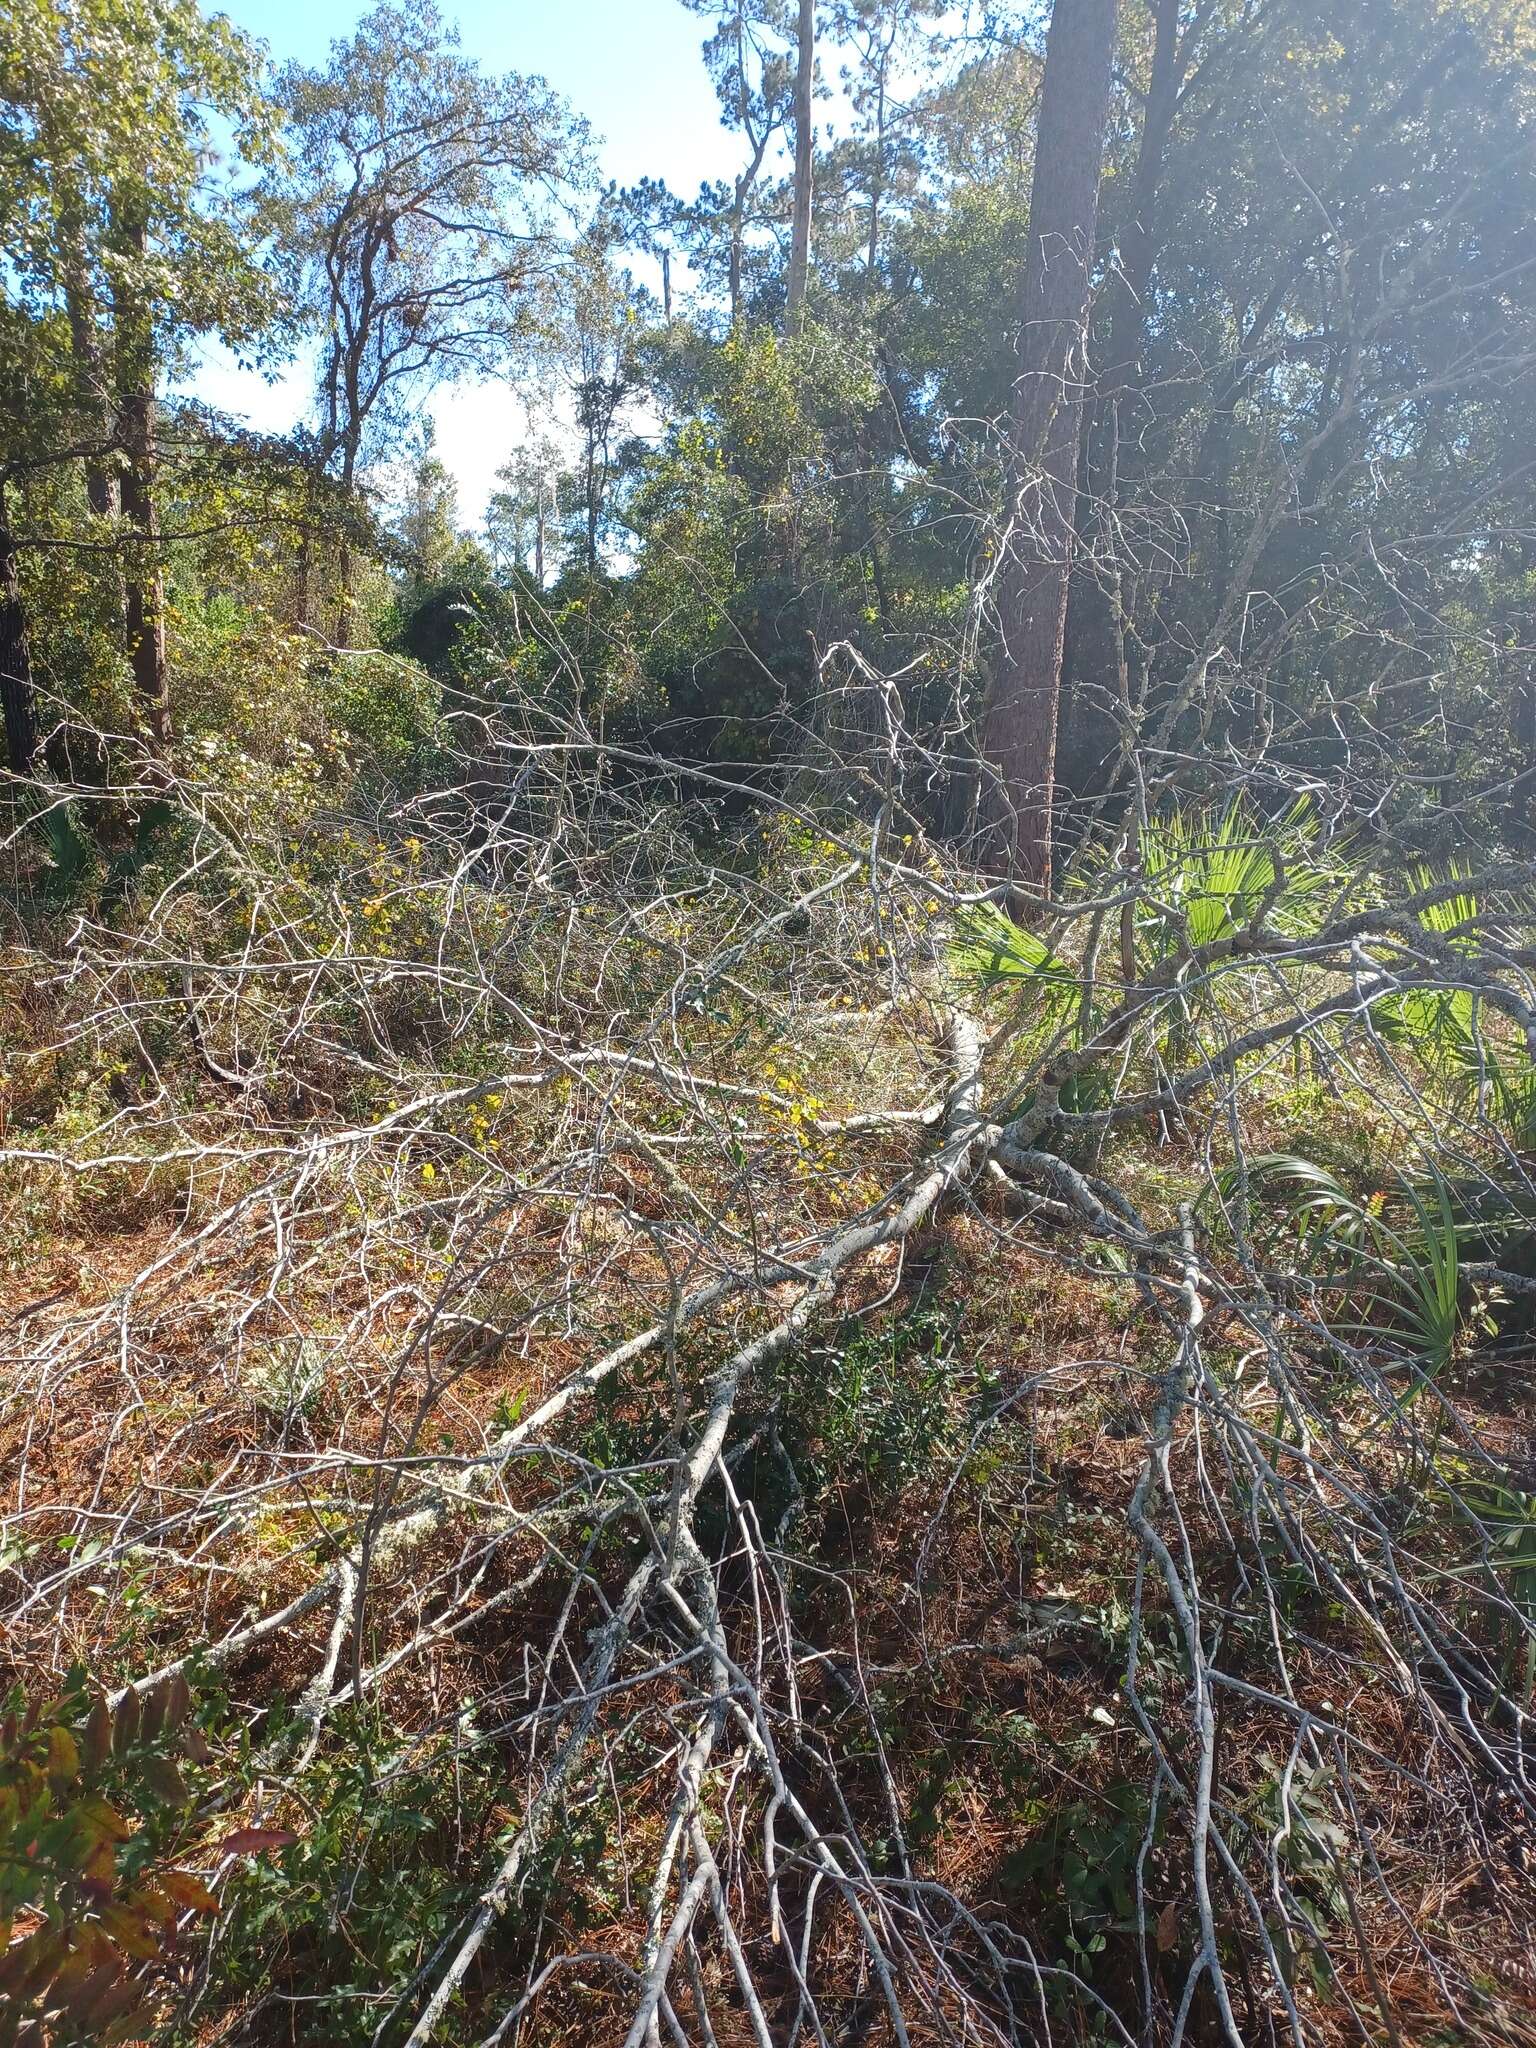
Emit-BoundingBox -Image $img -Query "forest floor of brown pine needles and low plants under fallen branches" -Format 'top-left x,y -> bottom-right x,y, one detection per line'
0,794 -> 1536,2048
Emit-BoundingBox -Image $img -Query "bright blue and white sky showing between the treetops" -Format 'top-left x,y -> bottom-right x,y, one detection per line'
195,0 -> 737,524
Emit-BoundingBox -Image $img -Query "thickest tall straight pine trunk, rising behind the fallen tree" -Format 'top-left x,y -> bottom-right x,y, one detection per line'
985,0 -> 1116,891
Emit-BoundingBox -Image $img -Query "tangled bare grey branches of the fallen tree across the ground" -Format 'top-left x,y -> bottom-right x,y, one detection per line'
0,651 -> 1536,2048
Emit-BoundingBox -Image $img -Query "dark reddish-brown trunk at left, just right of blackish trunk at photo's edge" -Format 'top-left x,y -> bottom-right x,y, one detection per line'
117,221 -> 170,752
